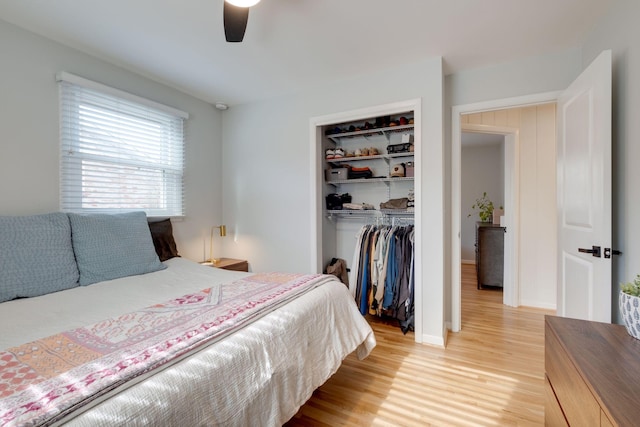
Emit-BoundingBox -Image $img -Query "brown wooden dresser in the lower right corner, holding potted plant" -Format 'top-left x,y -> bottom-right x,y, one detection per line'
545,316 -> 640,427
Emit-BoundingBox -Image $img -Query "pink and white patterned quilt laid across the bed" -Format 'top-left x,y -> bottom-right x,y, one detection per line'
0,273 -> 333,426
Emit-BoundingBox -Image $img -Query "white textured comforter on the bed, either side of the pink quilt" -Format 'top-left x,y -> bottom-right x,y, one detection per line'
0,258 -> 375,426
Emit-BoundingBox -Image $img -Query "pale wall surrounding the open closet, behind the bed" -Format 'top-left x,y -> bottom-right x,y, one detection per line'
223,58 -> 447,343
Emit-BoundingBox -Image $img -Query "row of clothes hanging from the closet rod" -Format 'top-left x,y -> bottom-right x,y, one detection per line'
350,225 -> 415,333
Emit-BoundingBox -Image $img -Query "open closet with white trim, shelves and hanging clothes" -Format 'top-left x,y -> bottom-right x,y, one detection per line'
311,101 -> 421,342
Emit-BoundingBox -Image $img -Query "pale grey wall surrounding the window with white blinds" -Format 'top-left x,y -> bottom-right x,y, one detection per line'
0,20 -> 222,261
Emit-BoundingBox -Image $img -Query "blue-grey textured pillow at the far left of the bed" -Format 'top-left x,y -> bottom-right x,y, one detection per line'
0,212 -> 78,302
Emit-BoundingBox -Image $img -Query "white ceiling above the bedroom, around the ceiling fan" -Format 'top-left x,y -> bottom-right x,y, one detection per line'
0,0 -> 618,105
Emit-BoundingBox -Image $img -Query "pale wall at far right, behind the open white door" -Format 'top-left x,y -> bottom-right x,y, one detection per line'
582,0 -> 640,323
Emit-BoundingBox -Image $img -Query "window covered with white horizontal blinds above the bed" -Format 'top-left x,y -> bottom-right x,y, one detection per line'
57,73 -> 188,217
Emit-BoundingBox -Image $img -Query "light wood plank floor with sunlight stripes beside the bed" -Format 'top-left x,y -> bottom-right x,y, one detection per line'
286,265 -> 551,427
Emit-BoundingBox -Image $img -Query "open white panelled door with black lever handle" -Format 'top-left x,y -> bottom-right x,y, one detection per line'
557,51 -> 612,322
